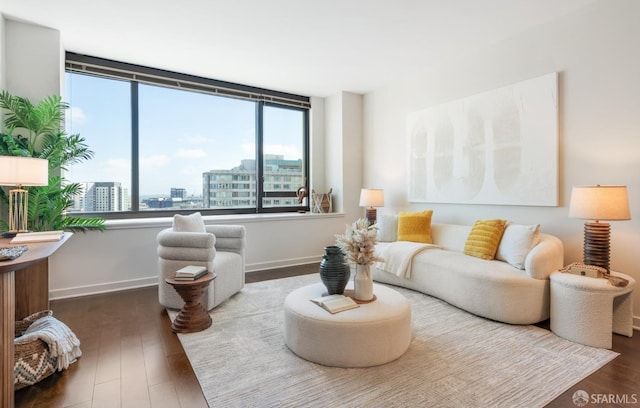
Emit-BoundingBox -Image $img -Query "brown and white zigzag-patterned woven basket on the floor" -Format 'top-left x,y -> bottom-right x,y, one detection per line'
13,310 -> 56,390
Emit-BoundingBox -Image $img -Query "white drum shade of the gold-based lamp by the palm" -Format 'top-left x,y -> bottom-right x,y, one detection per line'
0,156 -> 49,186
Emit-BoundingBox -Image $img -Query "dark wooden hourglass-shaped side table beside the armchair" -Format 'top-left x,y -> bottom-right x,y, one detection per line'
165,272 -> 216,333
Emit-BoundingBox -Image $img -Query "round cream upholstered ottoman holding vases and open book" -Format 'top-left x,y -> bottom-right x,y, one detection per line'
284,283 -> 411,367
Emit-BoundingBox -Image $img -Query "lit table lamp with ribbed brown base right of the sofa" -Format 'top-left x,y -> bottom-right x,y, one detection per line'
569,185 -> 631,273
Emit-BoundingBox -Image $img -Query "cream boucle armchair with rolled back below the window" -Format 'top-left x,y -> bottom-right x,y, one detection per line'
157,213 -> 246,310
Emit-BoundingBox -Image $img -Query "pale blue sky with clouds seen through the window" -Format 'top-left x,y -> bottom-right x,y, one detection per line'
66,74 -> 302,196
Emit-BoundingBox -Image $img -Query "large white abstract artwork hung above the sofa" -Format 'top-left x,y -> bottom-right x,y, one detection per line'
407,72 -> 558,206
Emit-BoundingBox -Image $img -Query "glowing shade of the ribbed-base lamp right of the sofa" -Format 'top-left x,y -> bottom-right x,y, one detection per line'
569,185 -> 631,221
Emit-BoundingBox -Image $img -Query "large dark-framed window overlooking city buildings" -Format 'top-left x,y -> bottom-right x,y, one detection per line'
65,54 -> 309,217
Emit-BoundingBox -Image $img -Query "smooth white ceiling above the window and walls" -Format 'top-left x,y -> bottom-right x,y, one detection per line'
0,0 -> 594,97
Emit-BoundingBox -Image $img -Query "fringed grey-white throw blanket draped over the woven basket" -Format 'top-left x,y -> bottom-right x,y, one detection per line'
16,316 -> 82,371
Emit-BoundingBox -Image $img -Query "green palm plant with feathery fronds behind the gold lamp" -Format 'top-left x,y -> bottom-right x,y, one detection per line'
0,91 -> 105,231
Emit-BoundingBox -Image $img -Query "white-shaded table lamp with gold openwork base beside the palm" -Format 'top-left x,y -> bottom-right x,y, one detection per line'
0,156 -> 49,237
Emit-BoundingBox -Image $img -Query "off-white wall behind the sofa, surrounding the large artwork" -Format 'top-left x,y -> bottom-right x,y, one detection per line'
363,0 -> 640,326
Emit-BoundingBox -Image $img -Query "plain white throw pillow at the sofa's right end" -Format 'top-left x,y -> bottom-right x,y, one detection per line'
496,223 -> 540,269
